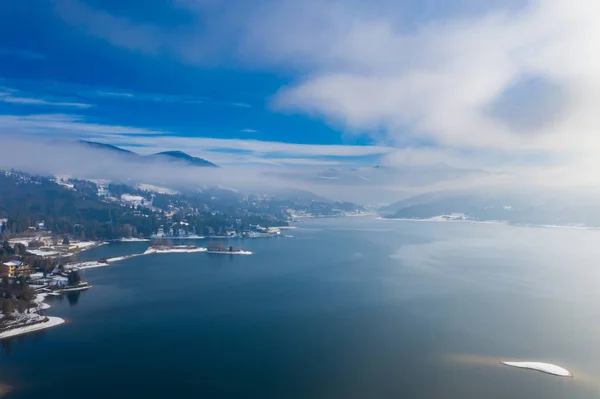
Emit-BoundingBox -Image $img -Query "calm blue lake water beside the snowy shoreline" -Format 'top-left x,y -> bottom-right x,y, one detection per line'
0,218 -> 600,399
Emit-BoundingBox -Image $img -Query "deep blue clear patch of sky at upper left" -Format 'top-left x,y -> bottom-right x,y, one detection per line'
0,0 -> 386,166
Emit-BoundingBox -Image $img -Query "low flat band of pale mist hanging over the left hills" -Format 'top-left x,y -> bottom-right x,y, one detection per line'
0,134 -> 500,203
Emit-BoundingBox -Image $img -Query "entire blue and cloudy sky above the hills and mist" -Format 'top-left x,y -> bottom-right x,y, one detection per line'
0,0 -> 600,202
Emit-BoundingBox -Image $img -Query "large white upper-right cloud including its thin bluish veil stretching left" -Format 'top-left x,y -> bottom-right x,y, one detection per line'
51,0 -> 600,189
